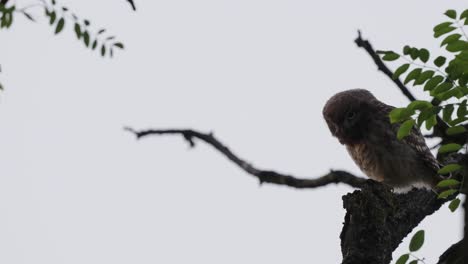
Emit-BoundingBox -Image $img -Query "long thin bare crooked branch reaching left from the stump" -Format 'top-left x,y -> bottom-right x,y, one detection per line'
125,127 -> 366,188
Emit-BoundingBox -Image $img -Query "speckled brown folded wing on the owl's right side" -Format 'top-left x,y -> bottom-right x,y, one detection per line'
379,103 -> 441,172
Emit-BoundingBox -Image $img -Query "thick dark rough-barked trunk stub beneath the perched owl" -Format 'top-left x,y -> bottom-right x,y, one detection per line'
340,180 -> 446,264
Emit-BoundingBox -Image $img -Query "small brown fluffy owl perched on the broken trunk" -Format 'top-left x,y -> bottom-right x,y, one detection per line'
323,89 -> 442,191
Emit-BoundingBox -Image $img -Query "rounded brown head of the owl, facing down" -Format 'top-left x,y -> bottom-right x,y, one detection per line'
323,89 -> 378,145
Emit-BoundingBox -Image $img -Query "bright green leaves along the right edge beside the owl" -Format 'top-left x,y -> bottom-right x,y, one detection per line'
377,9 -> 468,264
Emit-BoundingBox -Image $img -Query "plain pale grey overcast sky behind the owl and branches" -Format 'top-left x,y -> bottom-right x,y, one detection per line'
0,0 -> 466,264
